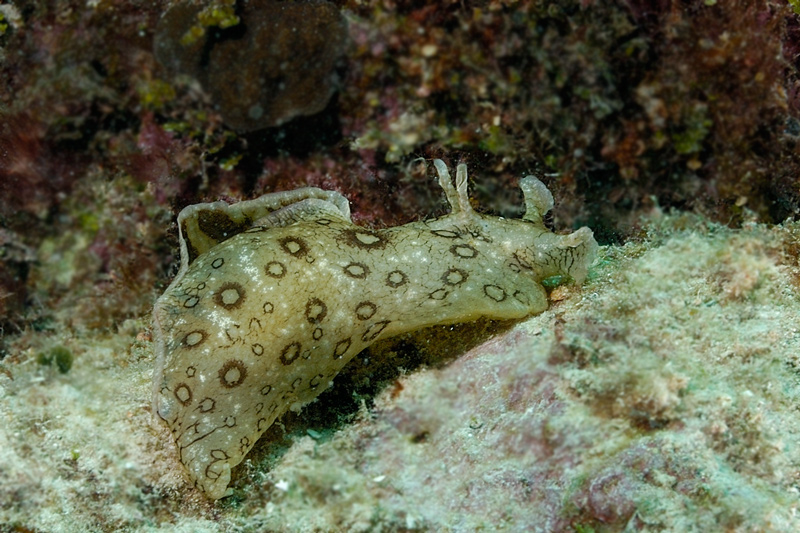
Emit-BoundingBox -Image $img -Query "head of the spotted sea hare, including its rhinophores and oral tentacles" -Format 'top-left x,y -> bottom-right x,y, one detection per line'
433,159 -> 597,283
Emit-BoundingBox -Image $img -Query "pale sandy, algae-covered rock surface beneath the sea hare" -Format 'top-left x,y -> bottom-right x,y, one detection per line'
0,216 -> 800,532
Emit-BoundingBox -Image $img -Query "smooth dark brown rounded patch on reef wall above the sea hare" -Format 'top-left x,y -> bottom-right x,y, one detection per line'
154,0 -> 348,132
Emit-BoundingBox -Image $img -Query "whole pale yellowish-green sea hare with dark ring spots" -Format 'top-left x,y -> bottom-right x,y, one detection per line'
153,159 -> 597,499
